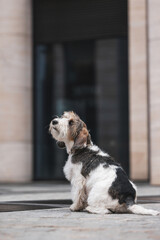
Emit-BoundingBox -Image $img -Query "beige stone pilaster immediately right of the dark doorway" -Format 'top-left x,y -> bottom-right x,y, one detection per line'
128,0 -> 148,180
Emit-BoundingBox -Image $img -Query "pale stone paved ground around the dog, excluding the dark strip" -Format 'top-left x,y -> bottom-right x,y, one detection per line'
0,183 -> 160,240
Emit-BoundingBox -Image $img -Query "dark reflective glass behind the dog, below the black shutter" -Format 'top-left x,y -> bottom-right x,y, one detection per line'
34,39 -> 128,179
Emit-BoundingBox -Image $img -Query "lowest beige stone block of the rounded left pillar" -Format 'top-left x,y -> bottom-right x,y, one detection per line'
0,142 -> 32,182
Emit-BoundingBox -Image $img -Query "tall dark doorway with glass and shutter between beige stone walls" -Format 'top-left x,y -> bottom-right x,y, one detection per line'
33,0 -> 129,180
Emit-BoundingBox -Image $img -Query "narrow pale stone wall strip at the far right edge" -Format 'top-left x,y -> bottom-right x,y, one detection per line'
148,0 -> 160,184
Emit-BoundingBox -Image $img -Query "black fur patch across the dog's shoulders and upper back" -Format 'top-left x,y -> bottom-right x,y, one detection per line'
72,147 -> 120,177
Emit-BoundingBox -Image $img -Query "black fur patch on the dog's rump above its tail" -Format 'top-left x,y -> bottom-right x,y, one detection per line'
109,168 -> 136,205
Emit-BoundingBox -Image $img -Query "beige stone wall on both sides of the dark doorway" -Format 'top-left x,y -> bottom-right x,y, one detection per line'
0,0 -> 160,184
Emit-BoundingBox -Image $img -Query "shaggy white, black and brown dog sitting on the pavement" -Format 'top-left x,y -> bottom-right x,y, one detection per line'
49,111 -> 159,215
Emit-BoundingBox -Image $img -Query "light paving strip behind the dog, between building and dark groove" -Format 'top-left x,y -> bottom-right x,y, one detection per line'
0,183 -> 160,202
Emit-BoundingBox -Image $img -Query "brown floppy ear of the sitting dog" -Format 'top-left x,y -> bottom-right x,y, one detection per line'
71,127 -> 90,152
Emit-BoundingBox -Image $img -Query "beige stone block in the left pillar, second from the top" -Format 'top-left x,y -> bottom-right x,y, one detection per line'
0,26 -> 32,88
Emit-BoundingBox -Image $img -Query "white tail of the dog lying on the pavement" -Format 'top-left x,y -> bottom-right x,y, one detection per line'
126,197 -> 160,216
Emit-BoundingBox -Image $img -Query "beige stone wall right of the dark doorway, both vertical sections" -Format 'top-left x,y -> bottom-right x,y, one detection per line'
128,0 -> 160,184
